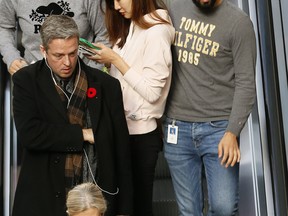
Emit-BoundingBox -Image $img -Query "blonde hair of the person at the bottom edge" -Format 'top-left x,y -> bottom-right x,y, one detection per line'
66,182 -> 107,215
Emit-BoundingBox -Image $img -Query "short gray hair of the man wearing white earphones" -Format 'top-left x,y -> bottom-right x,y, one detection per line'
40,15 -> 79,50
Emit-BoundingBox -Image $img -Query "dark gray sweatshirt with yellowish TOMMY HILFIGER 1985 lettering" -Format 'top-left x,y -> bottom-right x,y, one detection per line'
166,0 -> 256,136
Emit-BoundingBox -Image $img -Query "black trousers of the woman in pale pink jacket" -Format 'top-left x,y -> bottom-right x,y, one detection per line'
130,129 -> 162,216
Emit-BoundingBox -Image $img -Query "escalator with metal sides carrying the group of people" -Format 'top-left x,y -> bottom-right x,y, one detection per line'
0,0 -> 288,216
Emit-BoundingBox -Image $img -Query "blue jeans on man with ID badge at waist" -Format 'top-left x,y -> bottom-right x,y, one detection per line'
163,118 -> 239,216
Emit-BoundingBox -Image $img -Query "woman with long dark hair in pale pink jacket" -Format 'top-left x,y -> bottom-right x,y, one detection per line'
88,0 -> 175,216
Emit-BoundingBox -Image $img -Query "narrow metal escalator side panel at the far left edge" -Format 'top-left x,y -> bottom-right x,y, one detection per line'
0,57 -> 19,216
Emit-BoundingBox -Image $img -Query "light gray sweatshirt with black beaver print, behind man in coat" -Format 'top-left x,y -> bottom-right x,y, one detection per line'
0,0 -> 108,68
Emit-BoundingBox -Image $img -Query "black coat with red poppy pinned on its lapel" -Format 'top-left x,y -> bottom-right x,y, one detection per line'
12,60 -> 132,216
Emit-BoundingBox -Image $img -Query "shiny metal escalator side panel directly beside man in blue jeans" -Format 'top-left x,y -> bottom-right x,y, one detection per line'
233,0 -> 274,216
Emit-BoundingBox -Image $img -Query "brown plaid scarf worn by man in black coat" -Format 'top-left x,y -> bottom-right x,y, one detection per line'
56,66 -> 88,192
